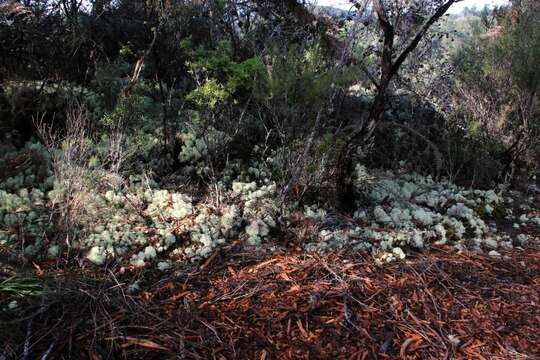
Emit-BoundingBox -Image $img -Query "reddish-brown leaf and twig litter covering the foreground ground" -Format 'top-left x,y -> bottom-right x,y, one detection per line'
1,250 -> 540,360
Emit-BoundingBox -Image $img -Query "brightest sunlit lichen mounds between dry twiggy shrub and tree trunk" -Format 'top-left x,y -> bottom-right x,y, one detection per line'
77,182 -> 277,270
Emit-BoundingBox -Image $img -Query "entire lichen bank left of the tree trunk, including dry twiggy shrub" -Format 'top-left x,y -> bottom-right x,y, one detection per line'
0,128 -> 278,268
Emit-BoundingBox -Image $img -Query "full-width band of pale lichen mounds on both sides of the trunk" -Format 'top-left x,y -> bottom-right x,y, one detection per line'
0,124 -> 540,270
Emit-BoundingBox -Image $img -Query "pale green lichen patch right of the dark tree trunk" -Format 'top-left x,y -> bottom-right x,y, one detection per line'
306,170 -> 527,262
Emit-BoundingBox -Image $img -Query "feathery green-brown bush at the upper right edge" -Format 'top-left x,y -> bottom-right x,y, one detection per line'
454,5 -> 540,179
